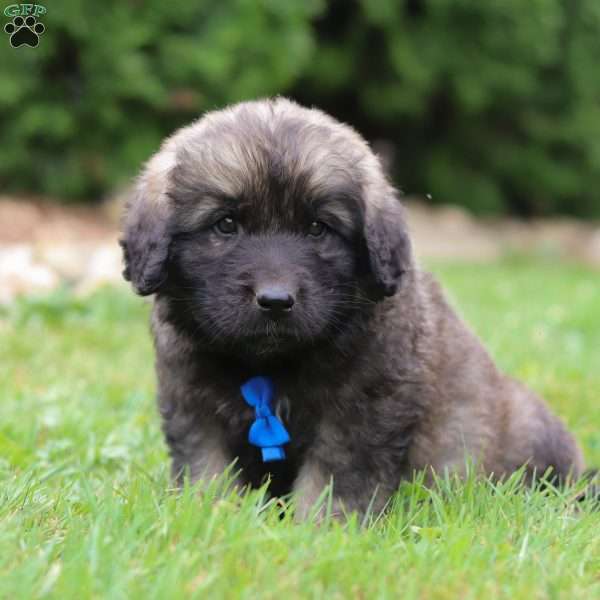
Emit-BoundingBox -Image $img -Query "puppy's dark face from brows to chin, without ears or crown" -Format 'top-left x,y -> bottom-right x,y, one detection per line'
170,188 -> 360,355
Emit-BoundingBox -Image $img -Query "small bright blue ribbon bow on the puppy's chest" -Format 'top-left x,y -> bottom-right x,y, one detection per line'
241,377 -> 290,462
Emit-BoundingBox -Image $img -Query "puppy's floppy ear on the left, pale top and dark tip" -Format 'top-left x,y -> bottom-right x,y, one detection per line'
120,153 -> 172,296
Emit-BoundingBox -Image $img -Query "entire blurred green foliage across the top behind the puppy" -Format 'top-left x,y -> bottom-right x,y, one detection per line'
0,0 -> 600,217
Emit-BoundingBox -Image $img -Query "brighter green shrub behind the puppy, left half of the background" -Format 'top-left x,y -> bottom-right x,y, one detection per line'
0,0 -> 320,199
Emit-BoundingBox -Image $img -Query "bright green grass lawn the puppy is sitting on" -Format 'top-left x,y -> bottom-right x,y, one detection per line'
0,261 -> 600,600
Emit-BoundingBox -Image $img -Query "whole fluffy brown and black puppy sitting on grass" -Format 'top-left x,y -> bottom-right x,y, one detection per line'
122,98 -> 583,516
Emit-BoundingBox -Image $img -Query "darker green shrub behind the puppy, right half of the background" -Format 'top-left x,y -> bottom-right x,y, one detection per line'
300,0 -> 600,216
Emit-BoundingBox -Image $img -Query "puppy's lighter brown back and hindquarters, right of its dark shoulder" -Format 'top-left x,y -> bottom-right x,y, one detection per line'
412,273 -> 584,480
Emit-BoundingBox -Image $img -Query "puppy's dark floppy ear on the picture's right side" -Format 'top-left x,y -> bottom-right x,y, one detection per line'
364,191 -> 413,300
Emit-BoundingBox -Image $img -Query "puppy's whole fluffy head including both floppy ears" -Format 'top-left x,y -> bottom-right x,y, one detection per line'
122,99 -> 412,354
